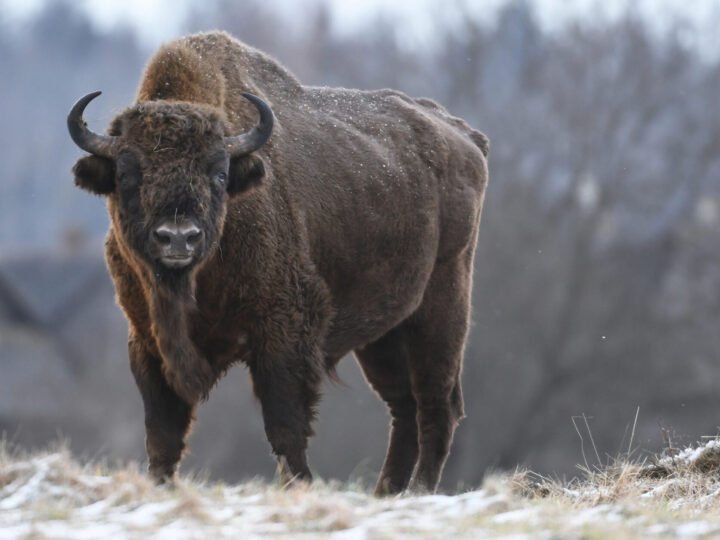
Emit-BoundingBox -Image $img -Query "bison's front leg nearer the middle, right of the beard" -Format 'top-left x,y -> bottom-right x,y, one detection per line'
250,350 -> 321,484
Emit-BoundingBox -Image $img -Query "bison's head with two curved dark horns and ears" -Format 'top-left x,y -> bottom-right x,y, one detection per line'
68,92 -> 273,276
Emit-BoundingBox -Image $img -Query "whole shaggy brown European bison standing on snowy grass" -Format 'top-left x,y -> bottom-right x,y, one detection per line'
68,32 -> 488,494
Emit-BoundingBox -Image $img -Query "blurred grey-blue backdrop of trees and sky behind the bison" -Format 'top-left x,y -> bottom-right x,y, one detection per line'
0,0 -> 720,489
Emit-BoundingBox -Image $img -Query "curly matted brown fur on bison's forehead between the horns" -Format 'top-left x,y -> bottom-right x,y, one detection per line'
109,101 -> 226,154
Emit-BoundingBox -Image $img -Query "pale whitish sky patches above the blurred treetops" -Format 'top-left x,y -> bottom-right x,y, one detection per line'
0,0 -> 720,55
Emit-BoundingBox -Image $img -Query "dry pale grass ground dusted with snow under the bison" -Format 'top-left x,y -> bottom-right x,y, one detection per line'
0,439 -> 720,540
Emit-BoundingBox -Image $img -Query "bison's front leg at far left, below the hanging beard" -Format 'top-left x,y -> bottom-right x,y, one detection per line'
128,338 -> 195,484
